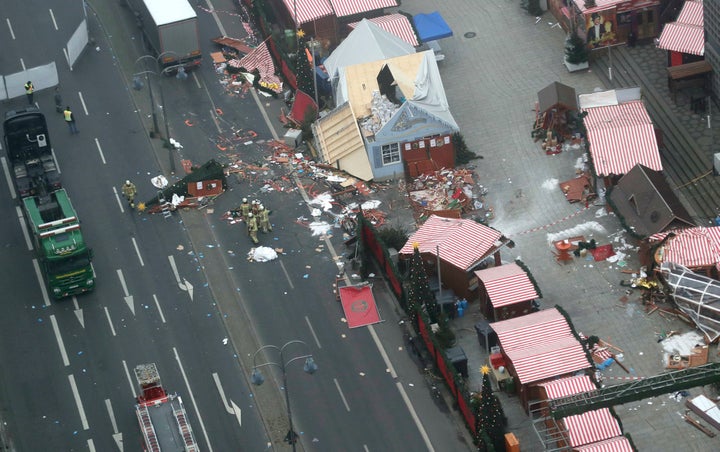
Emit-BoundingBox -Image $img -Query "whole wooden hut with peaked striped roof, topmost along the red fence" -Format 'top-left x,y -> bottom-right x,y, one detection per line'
398,215 -> 510,301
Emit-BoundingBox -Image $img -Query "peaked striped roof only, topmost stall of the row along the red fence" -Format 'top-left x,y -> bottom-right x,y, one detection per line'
400,215 -> 502,271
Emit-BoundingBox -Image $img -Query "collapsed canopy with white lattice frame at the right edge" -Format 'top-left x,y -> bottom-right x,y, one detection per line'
660,262 -> 720,342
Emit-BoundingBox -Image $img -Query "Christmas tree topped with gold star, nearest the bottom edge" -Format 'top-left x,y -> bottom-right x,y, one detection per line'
476,365 -> 507,452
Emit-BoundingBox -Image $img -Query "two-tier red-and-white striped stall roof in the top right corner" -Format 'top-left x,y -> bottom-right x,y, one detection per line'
658,0 -> 705,56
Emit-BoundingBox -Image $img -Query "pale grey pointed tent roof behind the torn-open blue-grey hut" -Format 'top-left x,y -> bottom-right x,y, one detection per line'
323,19 -> 415,82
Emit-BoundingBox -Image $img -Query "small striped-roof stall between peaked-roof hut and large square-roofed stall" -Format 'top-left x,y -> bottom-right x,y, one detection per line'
475,263 -> 539,321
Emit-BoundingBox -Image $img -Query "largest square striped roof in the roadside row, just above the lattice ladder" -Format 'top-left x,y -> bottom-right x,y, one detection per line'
492,308 -> 591,384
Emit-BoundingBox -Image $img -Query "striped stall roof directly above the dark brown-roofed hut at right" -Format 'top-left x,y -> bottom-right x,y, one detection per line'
584,100 -> 662,177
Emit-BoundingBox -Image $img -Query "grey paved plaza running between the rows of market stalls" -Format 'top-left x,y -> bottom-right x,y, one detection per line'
388,0 -> 717,451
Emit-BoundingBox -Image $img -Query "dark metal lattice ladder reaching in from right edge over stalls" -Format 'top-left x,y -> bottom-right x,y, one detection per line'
550,363 -> 720,419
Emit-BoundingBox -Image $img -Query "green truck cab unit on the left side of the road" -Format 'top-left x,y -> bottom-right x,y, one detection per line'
23,189 -> 95,299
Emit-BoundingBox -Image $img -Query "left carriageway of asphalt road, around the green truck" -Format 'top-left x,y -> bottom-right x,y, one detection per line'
0,2 -> 268,451
